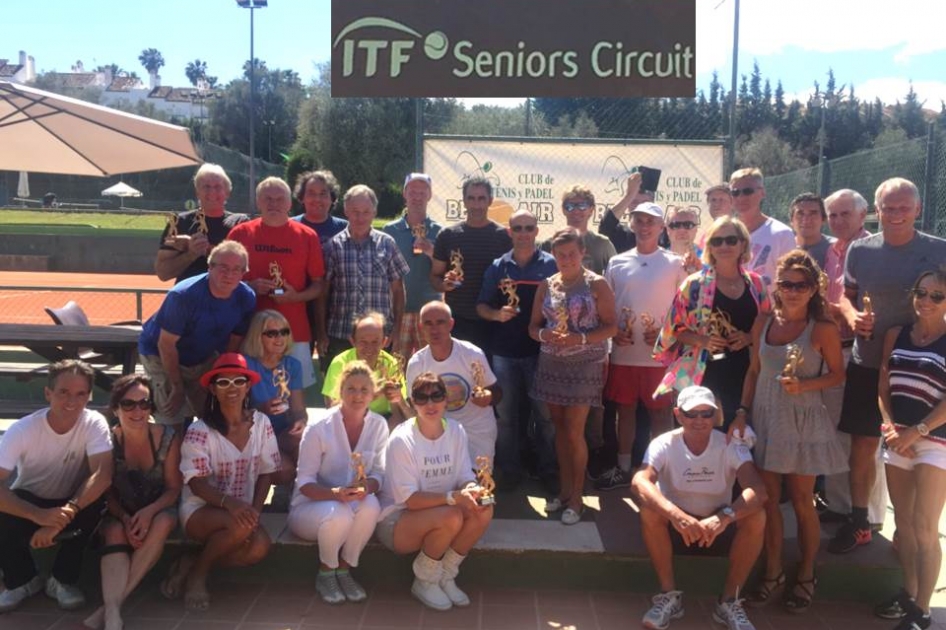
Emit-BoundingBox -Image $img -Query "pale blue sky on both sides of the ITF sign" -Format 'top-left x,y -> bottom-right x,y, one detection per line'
0,0 -> 946,111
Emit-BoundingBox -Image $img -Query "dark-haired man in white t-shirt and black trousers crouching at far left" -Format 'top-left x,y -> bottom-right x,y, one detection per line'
0,359 -> 112,612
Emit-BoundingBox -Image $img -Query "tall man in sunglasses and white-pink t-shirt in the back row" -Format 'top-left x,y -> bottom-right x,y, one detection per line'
729,168 -> 795,285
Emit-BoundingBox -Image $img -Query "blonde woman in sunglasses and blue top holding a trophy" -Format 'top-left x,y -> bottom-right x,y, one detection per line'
240,309 -> 307,484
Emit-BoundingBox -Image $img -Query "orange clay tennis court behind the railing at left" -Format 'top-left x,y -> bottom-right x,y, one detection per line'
0,271 -> 174,325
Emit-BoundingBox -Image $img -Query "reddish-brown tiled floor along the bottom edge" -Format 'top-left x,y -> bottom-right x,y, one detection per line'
0,583 -> 946,630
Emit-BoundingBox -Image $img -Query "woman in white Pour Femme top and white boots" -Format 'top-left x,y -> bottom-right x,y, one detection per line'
377,372 -> 493,610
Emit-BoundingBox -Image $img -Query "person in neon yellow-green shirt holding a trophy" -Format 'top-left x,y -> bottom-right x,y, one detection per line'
322,311 -> 414,430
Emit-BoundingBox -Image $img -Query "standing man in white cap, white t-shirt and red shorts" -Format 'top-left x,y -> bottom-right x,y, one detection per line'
594,202 -> 687,490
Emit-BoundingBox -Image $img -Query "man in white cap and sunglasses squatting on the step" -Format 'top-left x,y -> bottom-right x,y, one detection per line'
632,386 -> 765,630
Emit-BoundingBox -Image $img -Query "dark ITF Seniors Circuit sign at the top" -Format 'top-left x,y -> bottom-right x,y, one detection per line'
332,0 -> 696,97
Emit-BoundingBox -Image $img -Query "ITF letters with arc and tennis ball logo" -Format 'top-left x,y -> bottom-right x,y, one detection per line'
332,17 -> 450,78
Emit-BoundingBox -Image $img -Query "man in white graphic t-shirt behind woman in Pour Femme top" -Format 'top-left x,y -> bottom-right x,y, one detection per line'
407,301 -> 502,462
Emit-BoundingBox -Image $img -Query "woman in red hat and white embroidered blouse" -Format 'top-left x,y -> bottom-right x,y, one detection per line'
164,352 -> 279,610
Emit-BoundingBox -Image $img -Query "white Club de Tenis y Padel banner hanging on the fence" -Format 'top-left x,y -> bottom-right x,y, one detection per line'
424,138 -> 723,237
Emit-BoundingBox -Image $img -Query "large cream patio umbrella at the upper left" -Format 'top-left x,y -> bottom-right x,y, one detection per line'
0,81 -> 200,177
